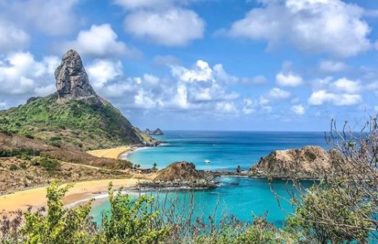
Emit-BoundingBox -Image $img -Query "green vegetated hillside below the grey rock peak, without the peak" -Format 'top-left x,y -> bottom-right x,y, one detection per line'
0,95 -> 154,150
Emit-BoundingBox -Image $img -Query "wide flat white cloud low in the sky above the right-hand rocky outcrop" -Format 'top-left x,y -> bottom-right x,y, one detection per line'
308,90 -> 362,106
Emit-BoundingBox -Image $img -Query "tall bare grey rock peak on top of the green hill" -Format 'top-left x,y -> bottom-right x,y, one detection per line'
55,49 -> 100,101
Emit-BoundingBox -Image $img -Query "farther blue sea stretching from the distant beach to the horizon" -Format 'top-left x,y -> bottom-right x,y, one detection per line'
128,131 -> 326,170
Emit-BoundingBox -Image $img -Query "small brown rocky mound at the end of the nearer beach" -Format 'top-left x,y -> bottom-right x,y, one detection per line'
142,161 -> 216,188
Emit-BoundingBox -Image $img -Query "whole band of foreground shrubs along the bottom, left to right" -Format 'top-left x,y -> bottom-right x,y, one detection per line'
0,179 -> 372,244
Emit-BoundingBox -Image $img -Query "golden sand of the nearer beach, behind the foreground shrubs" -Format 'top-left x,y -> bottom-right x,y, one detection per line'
0,179 -> 141,213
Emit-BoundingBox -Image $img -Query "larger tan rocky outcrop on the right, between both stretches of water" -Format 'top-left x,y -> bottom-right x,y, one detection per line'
251,146 -> 336,179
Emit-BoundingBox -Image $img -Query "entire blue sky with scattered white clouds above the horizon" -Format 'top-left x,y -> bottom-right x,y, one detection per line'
0,0 -> 378,131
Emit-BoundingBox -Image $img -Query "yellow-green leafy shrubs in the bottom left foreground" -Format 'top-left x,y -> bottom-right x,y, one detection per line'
0,182 -> 169,244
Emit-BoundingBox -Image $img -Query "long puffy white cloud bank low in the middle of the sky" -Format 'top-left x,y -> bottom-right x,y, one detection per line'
99,60 -> 239,114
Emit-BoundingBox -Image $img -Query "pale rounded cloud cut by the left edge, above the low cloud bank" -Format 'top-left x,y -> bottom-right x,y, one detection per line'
0,20 -> 30,52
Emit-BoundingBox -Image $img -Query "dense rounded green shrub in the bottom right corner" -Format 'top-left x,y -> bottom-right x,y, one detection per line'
287,186 -> 373,243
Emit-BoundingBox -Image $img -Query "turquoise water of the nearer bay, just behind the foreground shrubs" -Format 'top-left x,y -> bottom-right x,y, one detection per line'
92,177 -> 311,226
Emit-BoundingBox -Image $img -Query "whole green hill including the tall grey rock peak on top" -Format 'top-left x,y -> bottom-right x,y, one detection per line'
0,50 -> 156,150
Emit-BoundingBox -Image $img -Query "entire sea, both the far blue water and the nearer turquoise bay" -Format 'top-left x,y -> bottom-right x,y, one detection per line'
92,131 -> 327,226
